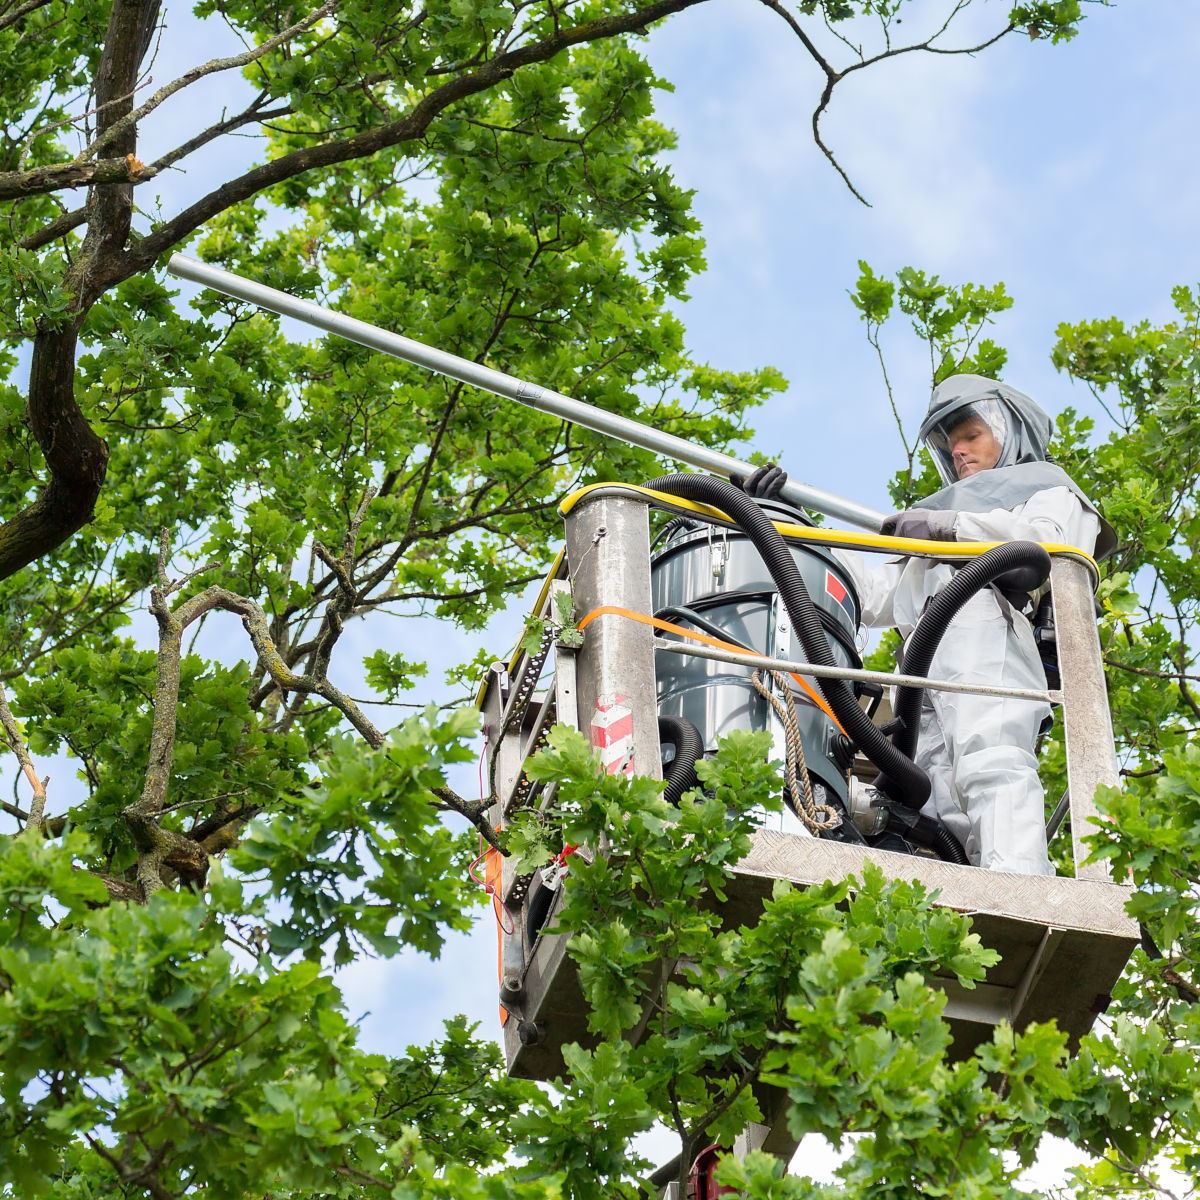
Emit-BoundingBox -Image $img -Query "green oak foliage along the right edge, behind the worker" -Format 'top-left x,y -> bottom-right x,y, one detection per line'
842,267 -> 1200,1196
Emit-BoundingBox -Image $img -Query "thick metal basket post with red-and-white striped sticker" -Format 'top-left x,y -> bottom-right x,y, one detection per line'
566,494 -> 662,779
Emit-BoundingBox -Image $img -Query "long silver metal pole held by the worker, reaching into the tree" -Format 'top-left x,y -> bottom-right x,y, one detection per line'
167,254 -> 883,529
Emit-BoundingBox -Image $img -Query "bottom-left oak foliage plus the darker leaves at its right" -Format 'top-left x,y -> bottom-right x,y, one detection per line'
0,820 -> 553,1200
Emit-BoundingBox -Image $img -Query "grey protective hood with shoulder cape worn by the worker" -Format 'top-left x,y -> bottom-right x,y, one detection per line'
913,374 -> 1117,559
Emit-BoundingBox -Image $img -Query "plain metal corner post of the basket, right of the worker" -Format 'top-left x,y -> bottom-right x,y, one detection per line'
1050,557 -> 1121,880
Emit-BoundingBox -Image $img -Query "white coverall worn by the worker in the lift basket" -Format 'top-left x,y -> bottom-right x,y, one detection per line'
834,376 -> 1100,875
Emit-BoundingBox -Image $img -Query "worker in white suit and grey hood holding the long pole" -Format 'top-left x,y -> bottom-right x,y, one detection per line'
744,374 -> 1115,875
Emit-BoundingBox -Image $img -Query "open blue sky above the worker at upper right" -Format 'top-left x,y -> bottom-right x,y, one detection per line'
650,0 -> 1200,508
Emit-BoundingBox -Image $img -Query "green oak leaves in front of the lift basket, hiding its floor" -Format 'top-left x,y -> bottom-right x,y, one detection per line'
506,728 -> 1067,1196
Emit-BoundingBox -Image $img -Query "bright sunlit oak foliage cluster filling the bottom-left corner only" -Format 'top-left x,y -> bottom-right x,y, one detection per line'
0,835 -> 383,1198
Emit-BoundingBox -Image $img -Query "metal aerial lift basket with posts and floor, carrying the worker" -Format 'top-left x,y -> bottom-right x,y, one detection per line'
481,485 -> 1139,1080
